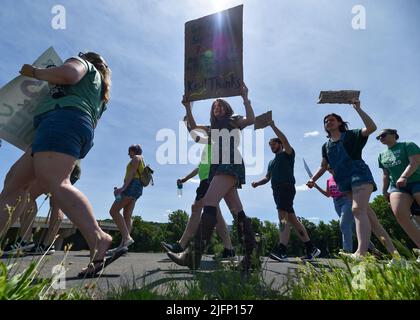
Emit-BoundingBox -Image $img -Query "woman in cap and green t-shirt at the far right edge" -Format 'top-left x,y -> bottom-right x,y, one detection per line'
376,129 -> 420,256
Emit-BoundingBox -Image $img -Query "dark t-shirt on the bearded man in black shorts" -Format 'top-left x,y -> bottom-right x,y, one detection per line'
267,149 -> 296,186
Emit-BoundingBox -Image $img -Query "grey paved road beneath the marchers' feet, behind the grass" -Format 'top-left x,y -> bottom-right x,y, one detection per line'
3,251 -> 342,296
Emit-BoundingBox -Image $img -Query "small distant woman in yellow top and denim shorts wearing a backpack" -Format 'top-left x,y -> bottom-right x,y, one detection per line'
108,144 -> 145,254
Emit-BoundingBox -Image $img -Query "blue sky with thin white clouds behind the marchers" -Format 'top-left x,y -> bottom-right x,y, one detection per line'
0,0 -> 420,222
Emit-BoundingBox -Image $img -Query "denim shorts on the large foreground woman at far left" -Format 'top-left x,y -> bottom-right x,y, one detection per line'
32,107 -> 94,159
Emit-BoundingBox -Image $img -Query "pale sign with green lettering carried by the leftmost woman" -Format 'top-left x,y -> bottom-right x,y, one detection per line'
0,47 -> 63,151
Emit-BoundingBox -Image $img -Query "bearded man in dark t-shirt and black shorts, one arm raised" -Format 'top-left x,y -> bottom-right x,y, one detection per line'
252,121 -> 321,261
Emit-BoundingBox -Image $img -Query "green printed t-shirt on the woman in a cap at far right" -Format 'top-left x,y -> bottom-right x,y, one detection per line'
378,142 -> 420,187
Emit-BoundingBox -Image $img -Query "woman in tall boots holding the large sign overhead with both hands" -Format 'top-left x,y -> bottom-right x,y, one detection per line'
168,84 -> 256,270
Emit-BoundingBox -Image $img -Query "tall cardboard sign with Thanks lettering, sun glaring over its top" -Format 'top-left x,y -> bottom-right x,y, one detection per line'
184,5 -> 243,101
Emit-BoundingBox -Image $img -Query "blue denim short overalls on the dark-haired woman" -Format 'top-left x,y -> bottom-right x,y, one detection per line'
327,132 -> 377,192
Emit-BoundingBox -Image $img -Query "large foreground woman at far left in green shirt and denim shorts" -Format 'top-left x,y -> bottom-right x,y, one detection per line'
0,52 -> 122,277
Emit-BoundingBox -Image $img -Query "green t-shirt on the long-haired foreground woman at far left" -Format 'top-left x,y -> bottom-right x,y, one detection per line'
35,57 -> 105,125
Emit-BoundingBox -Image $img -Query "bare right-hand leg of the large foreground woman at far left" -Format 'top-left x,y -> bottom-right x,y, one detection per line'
34,152 -> 112,260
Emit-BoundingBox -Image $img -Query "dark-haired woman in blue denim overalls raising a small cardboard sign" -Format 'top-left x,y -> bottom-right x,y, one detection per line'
307,99 -> 396,258
